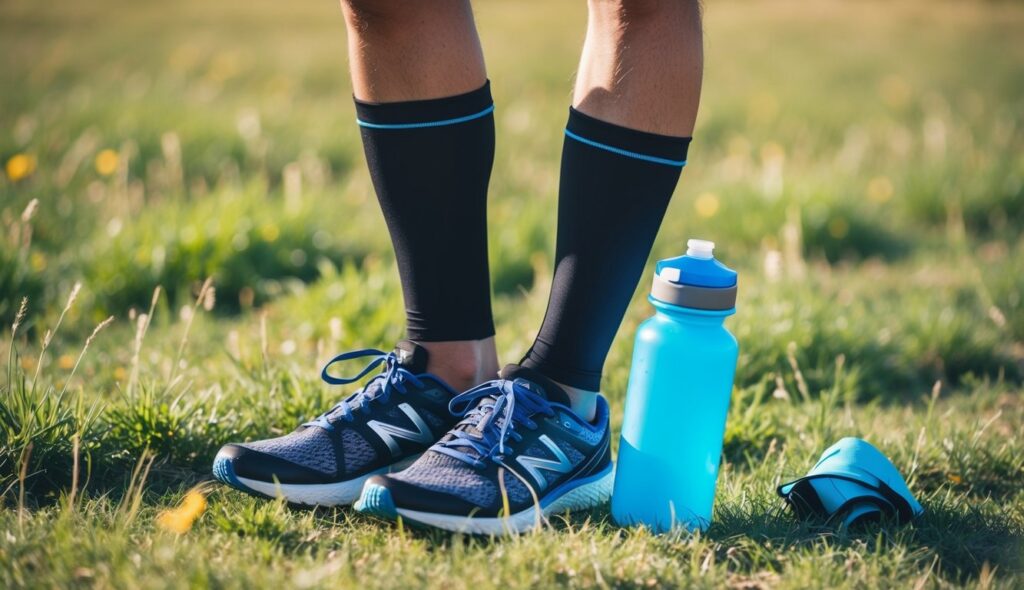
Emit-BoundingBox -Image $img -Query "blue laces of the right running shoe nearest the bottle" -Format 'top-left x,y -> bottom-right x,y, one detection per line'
431,379 -> 555,469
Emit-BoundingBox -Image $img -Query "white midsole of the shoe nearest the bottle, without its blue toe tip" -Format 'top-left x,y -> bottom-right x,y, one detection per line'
396,469 -> 615,536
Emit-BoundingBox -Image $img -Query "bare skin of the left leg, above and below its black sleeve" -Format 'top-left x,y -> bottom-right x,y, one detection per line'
341,0 -> 498,390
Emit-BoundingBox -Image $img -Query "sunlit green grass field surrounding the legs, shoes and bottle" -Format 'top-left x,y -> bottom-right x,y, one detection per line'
0,0 -> 1024,589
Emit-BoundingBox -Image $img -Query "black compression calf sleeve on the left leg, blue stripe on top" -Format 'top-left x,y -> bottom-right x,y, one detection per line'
355,82 -> 495,341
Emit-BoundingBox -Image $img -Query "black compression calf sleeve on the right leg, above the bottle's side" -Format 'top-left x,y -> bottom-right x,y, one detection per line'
522,109 -> 690,391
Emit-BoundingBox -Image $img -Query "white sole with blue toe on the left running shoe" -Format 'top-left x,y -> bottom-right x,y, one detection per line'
213,455 -> 420,506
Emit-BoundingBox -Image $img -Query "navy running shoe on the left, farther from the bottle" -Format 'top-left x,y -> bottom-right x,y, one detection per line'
213,340 -> 458,506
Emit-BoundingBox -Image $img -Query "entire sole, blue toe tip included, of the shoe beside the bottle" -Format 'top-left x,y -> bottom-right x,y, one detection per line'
354,465 -> 614,537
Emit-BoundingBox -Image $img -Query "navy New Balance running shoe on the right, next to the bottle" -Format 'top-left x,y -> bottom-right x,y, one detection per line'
355,365 -> 613,535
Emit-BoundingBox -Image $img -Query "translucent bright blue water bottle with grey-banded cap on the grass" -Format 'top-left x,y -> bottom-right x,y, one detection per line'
611,240 -> 739,532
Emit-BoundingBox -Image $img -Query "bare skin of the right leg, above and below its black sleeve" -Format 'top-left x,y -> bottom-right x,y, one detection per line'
566,0 -> 703,417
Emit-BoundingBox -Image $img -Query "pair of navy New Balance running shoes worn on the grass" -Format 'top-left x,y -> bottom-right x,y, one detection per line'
213,340 -> 613,535
